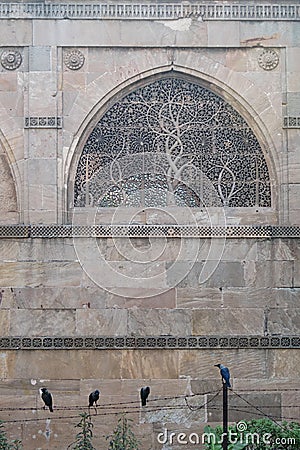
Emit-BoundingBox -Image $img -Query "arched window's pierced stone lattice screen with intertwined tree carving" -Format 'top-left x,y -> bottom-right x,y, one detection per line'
74,76 -> 271,207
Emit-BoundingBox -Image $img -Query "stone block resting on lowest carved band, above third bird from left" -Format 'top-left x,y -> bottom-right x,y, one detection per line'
128,309 -> 192,336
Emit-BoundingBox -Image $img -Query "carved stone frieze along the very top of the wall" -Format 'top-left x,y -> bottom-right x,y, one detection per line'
0,0 -> 300,21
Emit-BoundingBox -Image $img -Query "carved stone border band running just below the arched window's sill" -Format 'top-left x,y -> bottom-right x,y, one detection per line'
0,225 -> 300,239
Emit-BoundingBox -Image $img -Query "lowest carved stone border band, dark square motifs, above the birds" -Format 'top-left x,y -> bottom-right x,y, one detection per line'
0,336 -> 300,350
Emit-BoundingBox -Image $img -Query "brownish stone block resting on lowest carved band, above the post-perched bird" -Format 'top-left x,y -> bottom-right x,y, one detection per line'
193,308 -> 264,335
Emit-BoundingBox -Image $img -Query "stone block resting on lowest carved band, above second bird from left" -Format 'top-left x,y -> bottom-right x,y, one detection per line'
76,309 -> 127,336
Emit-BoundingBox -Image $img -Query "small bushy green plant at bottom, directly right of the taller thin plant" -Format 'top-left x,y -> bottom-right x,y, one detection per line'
106,414 -> 139,450
